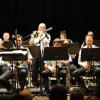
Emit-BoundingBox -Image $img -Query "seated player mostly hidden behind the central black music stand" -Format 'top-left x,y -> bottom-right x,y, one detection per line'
42,38 -> 76,92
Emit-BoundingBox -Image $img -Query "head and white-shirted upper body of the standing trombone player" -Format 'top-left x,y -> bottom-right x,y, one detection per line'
29,23 -> 51,50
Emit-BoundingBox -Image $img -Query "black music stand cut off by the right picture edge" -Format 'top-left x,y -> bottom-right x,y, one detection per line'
81,48 -> 100,94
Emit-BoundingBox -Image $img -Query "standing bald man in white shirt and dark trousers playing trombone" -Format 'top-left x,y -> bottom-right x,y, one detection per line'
29,23 -> 51,87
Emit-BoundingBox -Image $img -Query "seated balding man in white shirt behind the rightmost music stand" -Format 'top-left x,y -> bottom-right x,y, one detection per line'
73,35 -> 100,95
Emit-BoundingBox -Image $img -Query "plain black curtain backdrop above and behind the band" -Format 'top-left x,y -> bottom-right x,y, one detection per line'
0,0 -> 100,42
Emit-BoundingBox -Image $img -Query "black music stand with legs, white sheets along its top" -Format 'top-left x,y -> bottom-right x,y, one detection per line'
0,49 -> 28,93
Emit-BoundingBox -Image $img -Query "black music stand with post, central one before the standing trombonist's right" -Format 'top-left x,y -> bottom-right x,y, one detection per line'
43,47 -> 69,82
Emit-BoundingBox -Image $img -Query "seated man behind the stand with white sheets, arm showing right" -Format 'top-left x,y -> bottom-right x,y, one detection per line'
15,35 -> 33,89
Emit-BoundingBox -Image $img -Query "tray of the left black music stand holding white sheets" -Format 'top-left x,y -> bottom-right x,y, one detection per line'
0,49 -> 28,61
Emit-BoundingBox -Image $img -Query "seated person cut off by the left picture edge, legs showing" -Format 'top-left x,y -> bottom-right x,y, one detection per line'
0,38 -> 12,91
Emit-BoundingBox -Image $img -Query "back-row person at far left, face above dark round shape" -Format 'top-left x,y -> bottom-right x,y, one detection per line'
3,32 -> 14,49
